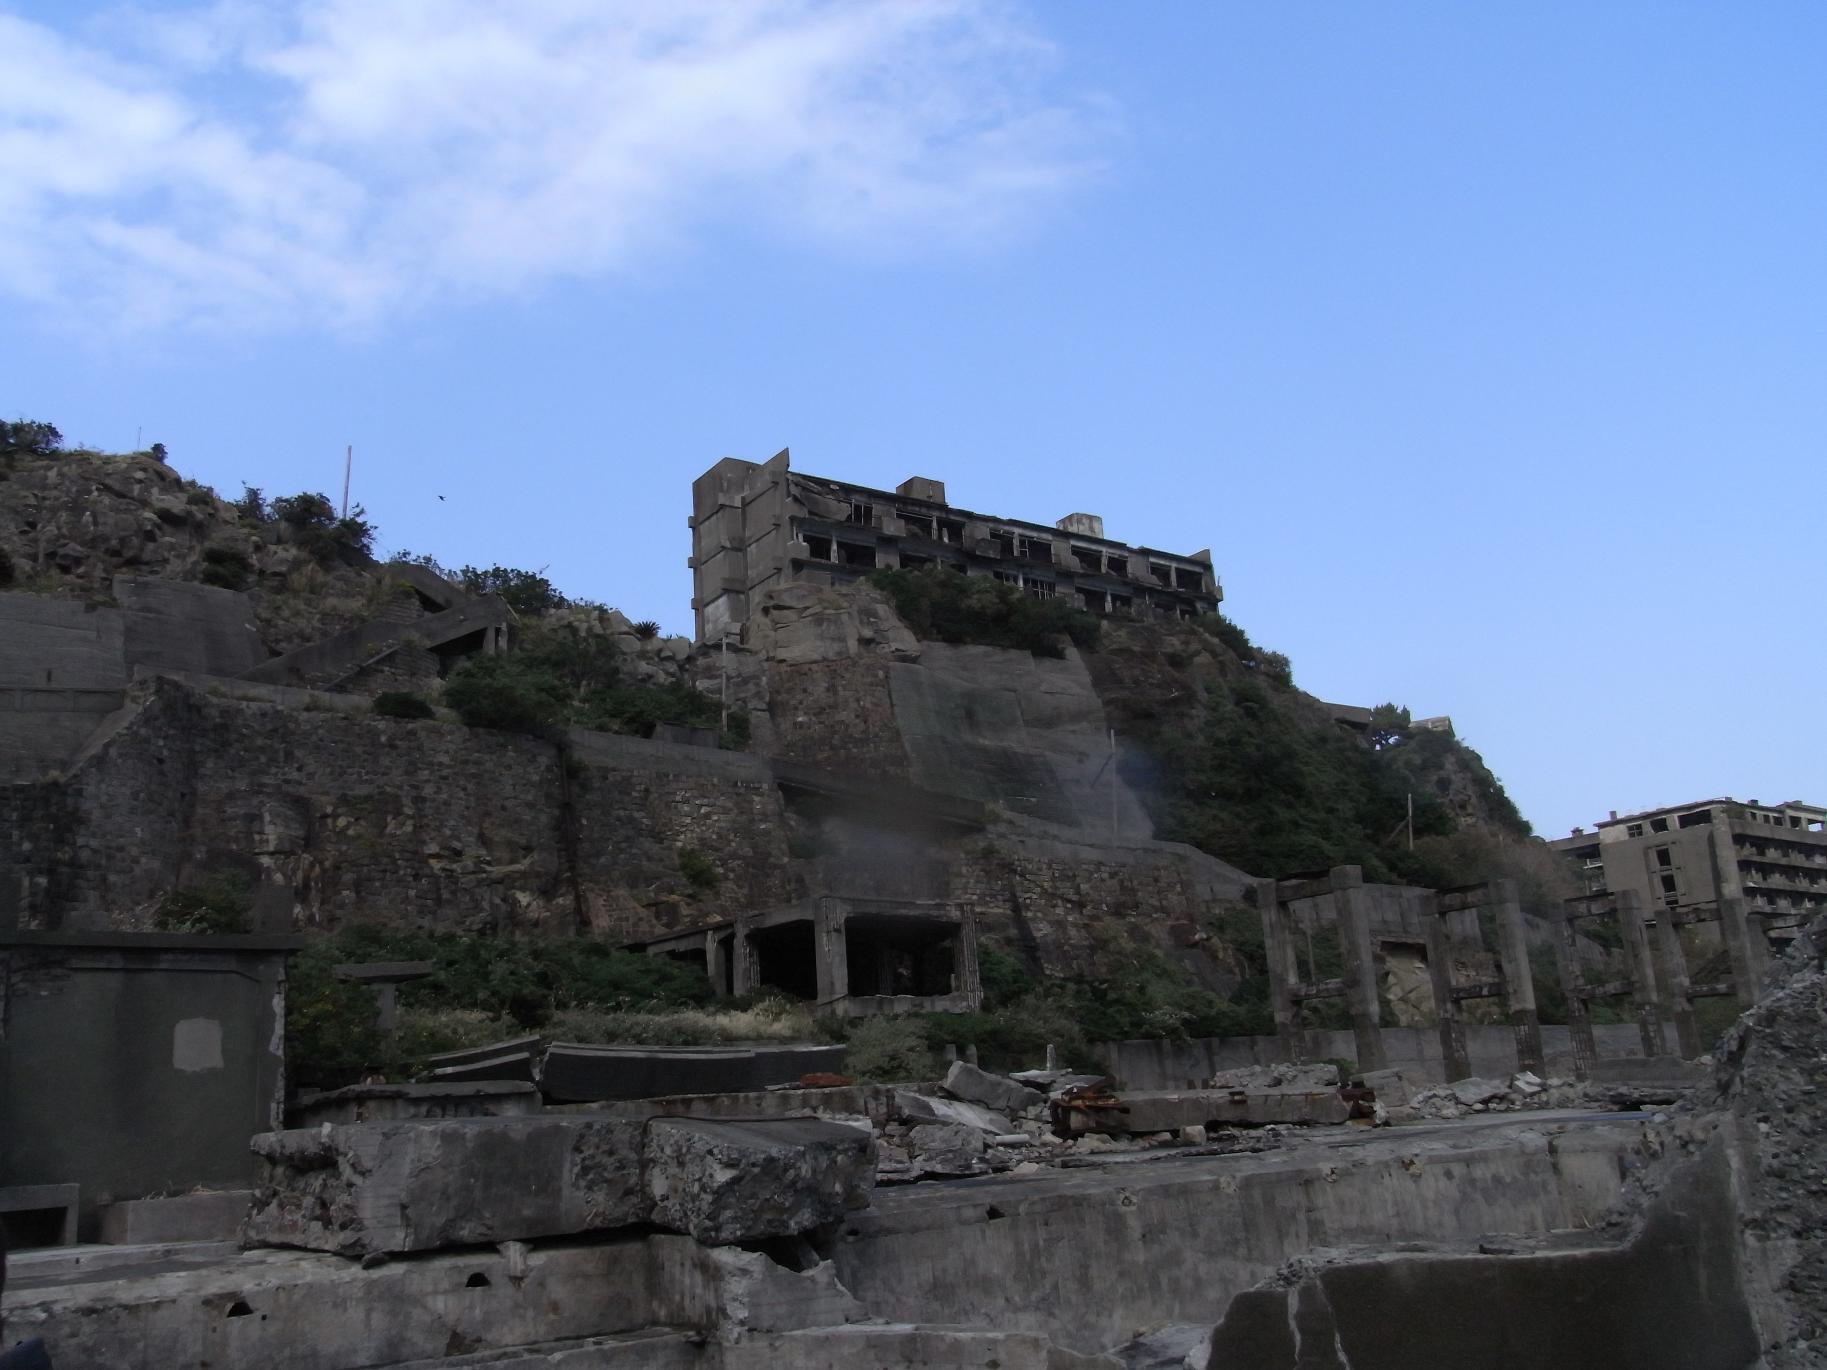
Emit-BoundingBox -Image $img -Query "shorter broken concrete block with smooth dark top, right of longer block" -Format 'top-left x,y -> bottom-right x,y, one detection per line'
647,1118 -> 875,1246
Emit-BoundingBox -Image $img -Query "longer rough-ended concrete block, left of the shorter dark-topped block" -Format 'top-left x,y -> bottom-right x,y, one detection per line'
243,1116 -> 649,1255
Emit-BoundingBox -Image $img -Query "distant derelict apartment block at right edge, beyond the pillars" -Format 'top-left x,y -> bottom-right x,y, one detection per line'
1549,798 -> 1827,937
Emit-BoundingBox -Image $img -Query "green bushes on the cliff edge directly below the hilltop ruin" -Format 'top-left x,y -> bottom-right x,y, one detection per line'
868,566 -> 1102,656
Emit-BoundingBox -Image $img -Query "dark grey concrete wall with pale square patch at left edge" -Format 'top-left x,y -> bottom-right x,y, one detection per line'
0,933 -> 289,1240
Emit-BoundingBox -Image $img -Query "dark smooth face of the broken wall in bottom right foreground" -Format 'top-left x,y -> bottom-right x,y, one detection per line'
1209,1142 -> 1758,1370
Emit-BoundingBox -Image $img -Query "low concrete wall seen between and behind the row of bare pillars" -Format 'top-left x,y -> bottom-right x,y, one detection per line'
1093,1023 -> 1666,1089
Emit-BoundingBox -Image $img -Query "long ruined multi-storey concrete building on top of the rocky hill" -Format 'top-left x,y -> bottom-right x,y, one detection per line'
691,451 -> 1224,641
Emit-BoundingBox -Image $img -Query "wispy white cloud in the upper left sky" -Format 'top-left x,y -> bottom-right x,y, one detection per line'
0,0 -> 1102,329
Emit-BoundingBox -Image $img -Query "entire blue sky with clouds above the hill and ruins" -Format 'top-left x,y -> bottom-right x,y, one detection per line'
0,0 -> 1827,835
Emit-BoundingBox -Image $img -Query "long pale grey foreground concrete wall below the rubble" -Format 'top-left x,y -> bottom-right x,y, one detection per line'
833,1116 -> 1648,1352
